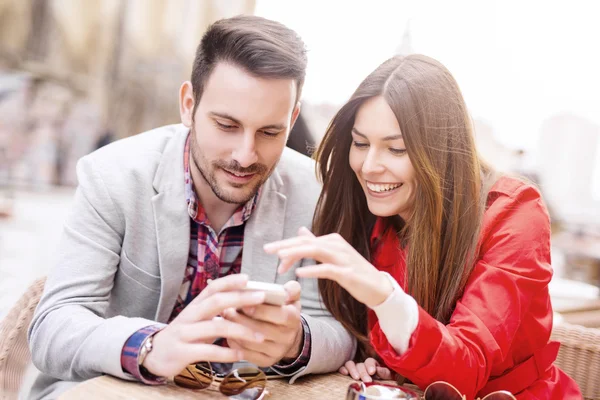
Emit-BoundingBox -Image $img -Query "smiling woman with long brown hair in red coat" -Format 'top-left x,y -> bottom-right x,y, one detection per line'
265,55 -> 581,400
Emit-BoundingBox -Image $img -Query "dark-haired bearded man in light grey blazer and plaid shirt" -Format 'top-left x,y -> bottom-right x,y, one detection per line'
29,16 -> 354,398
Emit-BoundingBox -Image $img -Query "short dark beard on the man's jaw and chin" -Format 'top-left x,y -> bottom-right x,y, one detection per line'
190,128 -> 276,204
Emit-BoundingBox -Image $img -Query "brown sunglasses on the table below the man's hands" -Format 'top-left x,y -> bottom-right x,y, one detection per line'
173,362 -> 269,400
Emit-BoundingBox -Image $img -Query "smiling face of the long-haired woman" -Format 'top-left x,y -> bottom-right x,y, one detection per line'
349,96 -> 417,221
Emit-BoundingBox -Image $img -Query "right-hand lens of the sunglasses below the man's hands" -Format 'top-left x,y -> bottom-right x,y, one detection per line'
219,367 -> 267,400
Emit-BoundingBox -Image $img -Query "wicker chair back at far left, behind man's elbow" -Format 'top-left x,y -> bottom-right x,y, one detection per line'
0,277 -> 46,400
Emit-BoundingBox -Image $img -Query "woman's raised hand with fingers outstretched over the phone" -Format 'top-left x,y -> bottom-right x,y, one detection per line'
264,228 -> 394,307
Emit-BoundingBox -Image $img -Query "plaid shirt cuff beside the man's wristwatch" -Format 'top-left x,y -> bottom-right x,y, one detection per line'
121,324 -> 166,385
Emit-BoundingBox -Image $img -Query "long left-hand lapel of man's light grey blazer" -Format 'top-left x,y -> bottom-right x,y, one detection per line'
152,125 -> 190,322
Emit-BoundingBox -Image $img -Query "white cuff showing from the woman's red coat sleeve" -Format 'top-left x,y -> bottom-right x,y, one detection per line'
371,272 -> 419,354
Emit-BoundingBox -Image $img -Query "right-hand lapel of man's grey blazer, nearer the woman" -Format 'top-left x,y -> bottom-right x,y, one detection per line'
242,169 -> 287,282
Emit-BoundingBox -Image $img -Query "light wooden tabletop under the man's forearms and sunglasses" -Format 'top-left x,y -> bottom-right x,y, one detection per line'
59,373 -> 406,400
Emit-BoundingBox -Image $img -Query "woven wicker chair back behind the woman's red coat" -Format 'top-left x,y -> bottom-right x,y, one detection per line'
552,323 -> 600,399
